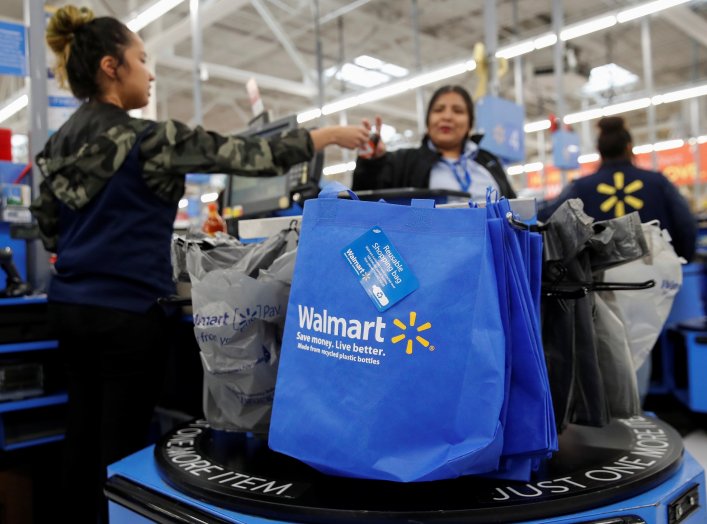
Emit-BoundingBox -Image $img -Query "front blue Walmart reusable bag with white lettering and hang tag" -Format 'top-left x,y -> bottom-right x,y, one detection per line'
269,184 -> 505,482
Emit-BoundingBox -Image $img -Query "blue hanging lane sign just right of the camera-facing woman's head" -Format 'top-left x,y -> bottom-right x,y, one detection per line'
476,95 -> 525,162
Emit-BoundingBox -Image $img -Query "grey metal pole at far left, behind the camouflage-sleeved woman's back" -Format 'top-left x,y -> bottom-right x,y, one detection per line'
23,0 -> 49,290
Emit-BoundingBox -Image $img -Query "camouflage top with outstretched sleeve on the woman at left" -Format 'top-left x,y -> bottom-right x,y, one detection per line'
30,102 -> 314,252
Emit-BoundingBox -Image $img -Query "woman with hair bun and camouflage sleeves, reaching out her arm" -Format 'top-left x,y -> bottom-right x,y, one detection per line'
31,5 -> 368,522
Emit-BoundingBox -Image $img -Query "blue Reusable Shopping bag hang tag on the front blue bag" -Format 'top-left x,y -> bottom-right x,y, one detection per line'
341,226 -> 420,311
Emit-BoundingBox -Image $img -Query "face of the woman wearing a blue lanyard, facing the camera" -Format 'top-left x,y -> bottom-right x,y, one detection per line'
427,91 -> 471,155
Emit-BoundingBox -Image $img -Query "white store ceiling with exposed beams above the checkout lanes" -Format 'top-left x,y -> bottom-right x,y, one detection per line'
0,0 -> 707,163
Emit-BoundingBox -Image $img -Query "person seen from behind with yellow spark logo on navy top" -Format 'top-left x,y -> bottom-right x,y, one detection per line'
538,116 -> 697,260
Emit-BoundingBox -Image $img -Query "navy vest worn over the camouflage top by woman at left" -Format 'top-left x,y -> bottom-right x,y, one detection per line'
49,128 -> 177,312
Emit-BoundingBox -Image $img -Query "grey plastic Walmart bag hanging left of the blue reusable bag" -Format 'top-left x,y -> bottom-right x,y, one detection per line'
192,231 -> 296,433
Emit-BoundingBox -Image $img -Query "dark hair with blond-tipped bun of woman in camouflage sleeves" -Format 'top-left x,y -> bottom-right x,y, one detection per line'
46,5 -> 133,100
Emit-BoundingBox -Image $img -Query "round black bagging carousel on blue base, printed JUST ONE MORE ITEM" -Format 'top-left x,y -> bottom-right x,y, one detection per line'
105,196 -> 707,524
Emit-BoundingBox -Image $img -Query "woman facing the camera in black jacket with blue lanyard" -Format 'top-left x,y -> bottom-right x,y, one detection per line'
352,85 -> 516,202
